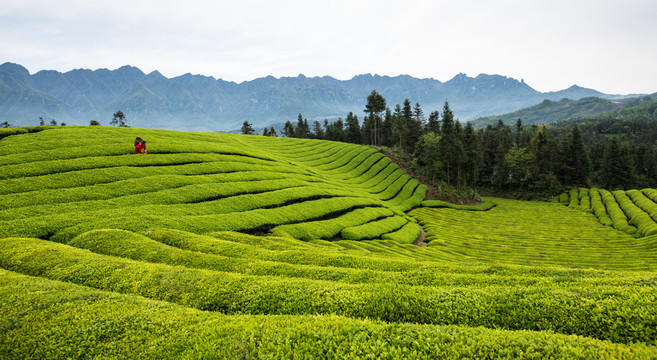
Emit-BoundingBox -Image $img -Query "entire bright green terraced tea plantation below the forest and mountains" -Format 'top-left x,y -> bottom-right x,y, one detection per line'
0,126 -> 657,359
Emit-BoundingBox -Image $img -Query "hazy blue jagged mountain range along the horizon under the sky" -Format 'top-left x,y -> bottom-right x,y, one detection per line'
0,62 -> 636,131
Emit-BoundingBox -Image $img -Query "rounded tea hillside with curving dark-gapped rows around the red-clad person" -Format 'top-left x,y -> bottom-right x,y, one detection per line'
0,127 -> 426,243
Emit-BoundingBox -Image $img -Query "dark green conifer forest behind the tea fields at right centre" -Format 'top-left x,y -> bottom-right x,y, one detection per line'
243,91 -> 657,198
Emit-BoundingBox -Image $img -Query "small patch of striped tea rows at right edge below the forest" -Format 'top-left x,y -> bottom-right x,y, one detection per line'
559,188 -> 657,237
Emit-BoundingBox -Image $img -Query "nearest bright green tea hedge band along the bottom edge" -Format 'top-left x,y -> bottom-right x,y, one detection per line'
0,270 -> 656,359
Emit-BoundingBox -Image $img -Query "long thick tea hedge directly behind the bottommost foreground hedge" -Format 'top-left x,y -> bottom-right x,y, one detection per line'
0,238 -> 657,345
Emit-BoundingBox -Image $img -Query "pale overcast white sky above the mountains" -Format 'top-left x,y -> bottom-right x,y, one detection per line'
0,0 -> 657,94
